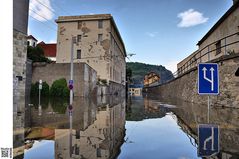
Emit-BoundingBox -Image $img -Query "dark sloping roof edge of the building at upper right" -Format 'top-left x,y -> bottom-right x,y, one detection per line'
197,1 -> 239,45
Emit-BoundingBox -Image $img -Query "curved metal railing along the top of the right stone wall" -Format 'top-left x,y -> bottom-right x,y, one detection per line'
173,32 -> 239,78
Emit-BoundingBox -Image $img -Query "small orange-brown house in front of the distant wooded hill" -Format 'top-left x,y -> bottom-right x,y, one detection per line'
144,72 -> 160,87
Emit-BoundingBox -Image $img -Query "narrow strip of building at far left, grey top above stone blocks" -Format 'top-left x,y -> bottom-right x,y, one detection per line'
13,0 -> 29,157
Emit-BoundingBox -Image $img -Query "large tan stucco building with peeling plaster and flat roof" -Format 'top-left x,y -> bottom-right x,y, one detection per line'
56,14 -> 126,84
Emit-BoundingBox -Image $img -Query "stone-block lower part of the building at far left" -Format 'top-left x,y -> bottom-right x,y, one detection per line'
13,29 -> 27,157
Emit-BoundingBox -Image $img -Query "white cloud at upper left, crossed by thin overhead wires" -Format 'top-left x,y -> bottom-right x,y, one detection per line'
29,0 -> 54,21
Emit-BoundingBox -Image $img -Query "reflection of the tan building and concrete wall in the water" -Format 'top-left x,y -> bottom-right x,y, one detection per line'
21,96 -> 125,159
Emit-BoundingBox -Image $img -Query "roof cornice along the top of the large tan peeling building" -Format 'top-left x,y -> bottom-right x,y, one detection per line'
55,14 -> 127,57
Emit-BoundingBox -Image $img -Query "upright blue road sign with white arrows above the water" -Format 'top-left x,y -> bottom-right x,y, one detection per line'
198,63 -> 219,95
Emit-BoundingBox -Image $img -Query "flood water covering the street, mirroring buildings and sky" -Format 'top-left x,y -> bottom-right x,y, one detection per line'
14,96 -> 239,159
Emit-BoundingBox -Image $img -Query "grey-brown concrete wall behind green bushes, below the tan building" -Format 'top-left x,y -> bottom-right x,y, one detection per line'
32,63 -> 97,97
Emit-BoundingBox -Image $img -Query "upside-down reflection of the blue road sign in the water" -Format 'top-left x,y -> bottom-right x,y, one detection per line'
198,124 -> 219,157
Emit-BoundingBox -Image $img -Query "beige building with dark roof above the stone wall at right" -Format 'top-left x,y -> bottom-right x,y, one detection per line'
177,0 -> 239,75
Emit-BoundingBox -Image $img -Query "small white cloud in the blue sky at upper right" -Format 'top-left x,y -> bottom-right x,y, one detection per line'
178,9 -> 209,27
